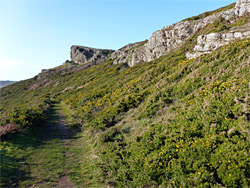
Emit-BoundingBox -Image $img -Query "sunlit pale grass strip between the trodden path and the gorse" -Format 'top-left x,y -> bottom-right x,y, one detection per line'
61,103 -> 103,188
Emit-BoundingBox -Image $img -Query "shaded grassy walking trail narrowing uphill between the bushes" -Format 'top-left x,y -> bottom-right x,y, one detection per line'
29,104 -> 76,188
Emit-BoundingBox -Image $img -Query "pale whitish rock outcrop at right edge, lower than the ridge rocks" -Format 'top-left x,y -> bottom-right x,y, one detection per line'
186,31 -> 250,59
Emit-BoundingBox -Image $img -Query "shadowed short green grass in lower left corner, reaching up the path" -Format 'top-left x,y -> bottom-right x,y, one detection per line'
0,104 -> 78,187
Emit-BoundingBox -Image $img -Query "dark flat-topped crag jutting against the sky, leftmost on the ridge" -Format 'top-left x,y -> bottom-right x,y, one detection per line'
70,46 -> 114,64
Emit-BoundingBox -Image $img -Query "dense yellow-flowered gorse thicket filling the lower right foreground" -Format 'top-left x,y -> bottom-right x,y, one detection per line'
103,79 -> 250,187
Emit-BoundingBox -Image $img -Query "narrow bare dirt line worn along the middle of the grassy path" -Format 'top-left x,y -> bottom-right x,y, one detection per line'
58,111 -> 75,188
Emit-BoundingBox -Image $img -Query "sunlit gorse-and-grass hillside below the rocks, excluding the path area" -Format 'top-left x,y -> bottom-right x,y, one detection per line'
1,5 -> 250,187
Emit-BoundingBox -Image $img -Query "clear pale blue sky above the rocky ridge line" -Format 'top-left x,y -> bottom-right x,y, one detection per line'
0,0 -> 236,81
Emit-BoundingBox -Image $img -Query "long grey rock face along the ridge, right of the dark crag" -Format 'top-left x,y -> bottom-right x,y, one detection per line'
111,9 -> 235,66
